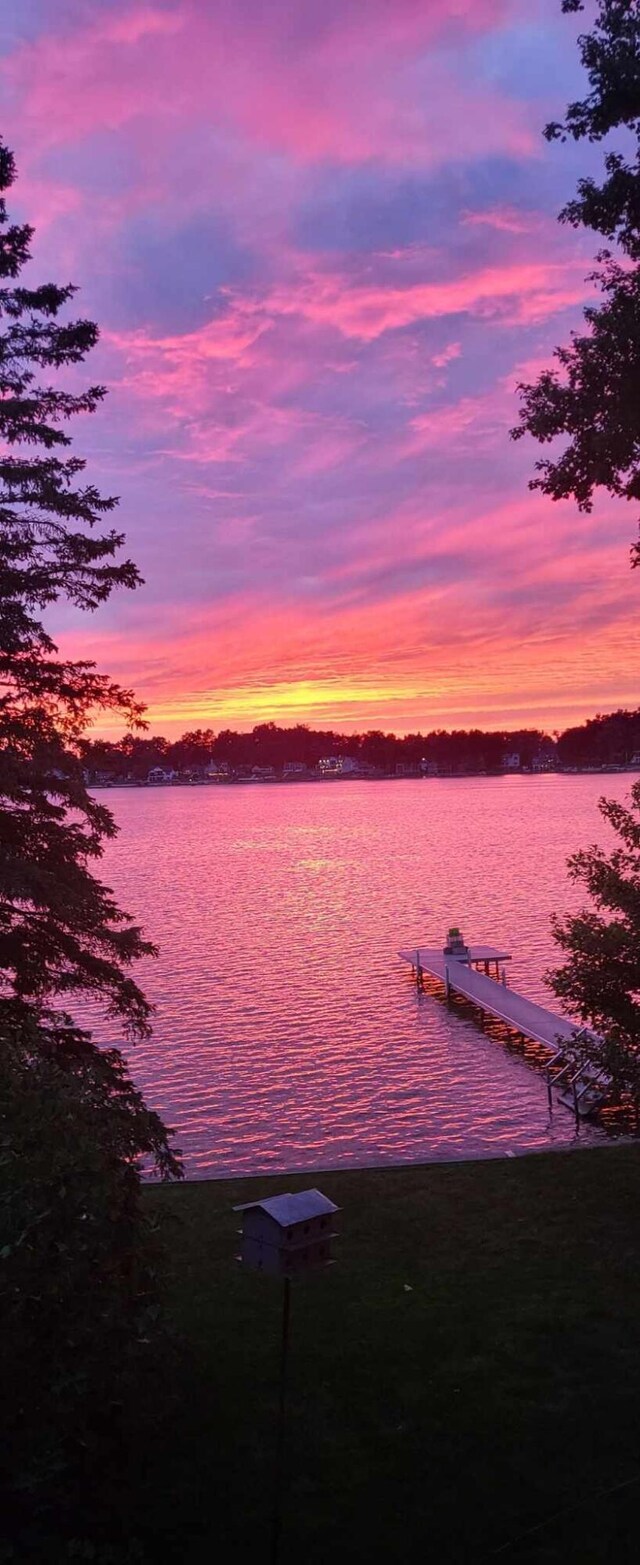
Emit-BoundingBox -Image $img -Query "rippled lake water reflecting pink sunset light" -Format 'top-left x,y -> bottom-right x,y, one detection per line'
102,776 -> 634,1178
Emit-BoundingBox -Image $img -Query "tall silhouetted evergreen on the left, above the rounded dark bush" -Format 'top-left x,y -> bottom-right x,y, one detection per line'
0,144 -> 158,1034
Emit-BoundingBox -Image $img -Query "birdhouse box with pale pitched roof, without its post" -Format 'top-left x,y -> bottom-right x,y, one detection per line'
233,1189 -> 340,1277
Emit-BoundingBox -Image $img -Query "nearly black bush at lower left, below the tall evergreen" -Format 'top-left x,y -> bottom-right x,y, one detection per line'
0,1011 -> 180,1535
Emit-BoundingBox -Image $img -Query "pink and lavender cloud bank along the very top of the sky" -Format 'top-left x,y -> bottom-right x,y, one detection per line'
5,0 -> 537,176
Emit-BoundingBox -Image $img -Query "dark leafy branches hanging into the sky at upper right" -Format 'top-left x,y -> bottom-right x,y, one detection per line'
513,0 -> 640,563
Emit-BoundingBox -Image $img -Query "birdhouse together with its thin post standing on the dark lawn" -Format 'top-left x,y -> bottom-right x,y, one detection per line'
233,1189 -> 340,1565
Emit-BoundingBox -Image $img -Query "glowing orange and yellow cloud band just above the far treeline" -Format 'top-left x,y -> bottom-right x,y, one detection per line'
57,505 -> 638,731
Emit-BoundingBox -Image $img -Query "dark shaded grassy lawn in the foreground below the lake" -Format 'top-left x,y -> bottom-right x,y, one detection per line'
89,1147 -> 640,1565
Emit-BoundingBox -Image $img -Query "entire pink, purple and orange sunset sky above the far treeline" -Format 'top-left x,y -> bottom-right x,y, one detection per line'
2,0 -> 640,734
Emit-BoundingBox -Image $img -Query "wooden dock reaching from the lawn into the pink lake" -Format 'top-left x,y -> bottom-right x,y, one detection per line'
397,945 -> 606,1117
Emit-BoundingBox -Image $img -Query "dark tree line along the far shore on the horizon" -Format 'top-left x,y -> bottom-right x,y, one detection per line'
80,707 -> 640,781
